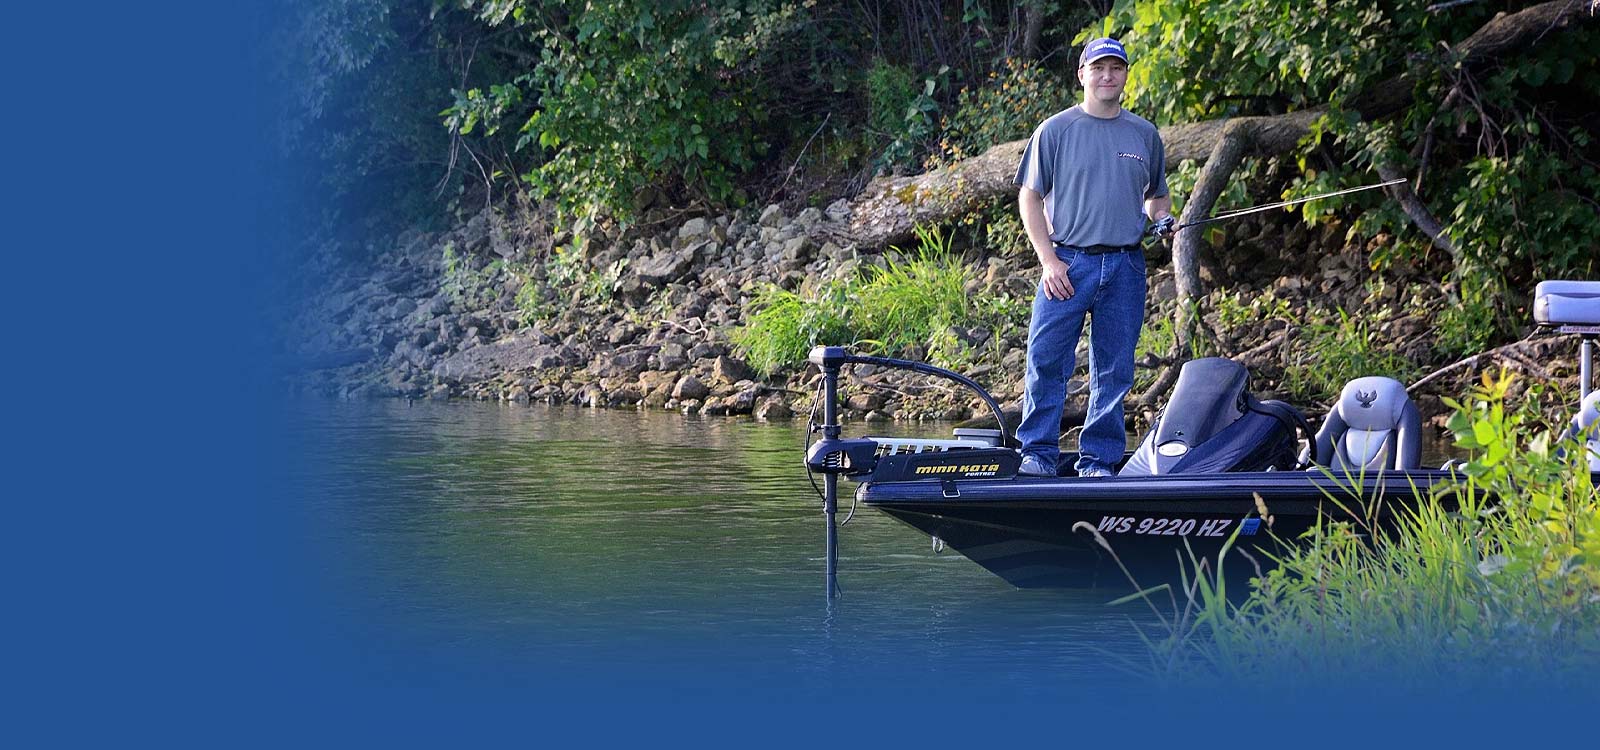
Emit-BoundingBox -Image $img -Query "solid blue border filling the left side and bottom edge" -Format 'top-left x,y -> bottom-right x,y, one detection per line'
9,3 -> 1600,747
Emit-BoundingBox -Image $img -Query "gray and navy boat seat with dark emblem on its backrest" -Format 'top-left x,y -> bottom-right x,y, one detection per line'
1317,376 -> 1422,472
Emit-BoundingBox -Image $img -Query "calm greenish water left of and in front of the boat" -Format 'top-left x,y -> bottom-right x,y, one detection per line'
290,400 -> 1154,691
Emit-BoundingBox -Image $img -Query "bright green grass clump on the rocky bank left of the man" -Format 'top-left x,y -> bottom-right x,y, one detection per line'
731,229 -> 978,374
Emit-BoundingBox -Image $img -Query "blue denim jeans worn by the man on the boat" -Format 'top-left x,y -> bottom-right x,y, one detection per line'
1016,246 -> 1146,472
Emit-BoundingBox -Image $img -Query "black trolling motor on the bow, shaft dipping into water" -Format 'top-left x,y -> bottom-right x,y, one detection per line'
805,345 -> 1014,598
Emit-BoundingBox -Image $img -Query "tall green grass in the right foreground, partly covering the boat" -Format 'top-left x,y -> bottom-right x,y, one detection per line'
1126,374 -> 1600,686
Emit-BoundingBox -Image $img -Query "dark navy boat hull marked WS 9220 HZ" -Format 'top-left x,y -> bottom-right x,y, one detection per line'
856,470 -> 1451,588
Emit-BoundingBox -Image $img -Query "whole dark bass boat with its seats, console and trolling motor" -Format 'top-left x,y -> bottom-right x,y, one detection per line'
806,281 -> 1600,595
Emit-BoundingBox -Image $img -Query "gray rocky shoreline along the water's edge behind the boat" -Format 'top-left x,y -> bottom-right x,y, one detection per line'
278,190 -> 1587,424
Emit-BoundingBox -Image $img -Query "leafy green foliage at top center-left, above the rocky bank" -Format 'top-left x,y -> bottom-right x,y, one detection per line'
445,0 -> 811,228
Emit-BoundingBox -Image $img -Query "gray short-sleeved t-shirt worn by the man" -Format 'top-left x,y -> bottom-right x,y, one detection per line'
1014,106 -> 1166,248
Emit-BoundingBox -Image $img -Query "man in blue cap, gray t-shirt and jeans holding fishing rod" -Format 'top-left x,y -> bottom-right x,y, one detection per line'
1014,38 -> 1176,477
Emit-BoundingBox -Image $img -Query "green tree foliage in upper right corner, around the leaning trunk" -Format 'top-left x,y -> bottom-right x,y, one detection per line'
1113,0 -> 1600,353
